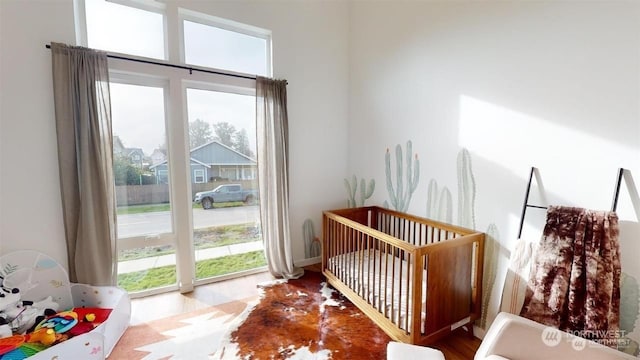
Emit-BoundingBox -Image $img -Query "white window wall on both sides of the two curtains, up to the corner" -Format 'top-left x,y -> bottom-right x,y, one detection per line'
0,0 -> 348,264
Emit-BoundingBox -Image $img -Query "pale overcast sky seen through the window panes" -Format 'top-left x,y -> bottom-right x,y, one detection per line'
86,0 -> 266,155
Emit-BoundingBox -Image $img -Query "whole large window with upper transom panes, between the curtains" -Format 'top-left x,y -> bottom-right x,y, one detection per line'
79,0 -> 271,296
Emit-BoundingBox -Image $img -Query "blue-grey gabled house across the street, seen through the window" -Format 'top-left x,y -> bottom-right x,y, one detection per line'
149,141 -> 258,184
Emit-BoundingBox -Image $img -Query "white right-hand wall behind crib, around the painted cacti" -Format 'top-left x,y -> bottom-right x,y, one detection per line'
349,2 -> 640,337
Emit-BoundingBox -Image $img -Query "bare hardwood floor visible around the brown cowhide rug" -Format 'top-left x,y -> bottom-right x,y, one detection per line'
131,264 -> 481,360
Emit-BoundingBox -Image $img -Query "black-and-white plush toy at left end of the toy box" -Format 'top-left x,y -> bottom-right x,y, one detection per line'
0,276 -> 58,338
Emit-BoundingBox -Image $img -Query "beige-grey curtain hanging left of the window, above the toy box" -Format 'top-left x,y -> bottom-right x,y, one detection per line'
51,43 -> 116,285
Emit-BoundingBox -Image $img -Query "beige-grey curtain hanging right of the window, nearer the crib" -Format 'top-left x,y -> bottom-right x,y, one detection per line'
256,76 -> 304,279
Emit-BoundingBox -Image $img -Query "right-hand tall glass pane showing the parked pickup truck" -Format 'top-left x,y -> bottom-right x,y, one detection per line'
186,88 -> 266,281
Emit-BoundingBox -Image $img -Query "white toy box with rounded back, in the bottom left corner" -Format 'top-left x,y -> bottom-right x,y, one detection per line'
0,250 -> 131,360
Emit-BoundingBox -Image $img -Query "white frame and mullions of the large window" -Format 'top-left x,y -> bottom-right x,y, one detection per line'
74,0 -> 272,298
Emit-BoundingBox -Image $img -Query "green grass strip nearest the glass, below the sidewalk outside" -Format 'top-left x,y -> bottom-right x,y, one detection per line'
118,251 -> 267,292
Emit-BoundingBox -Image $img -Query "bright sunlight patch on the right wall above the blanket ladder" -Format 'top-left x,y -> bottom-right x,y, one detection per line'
458,95 -> 638,217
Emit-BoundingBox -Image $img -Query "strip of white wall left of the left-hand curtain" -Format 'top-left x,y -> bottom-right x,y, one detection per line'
0,0 -> 75,264
